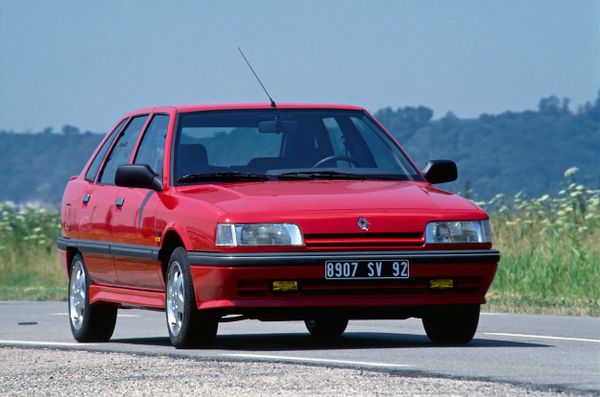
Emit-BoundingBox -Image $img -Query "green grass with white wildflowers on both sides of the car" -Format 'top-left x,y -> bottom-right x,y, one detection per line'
0,169 -> 600,316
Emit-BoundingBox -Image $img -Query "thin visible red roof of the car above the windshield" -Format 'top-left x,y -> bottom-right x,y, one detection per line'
127,103 -> 364,116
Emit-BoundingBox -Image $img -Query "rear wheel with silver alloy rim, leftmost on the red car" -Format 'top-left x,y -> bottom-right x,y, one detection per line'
69,254 -> 118,342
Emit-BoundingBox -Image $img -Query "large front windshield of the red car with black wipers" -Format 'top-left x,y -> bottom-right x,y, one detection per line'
173,109 -> 422,184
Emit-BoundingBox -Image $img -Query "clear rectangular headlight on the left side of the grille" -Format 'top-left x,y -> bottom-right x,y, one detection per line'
216,223 -> 304,247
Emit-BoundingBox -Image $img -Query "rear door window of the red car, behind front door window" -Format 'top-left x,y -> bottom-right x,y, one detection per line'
100,116 -> 148,185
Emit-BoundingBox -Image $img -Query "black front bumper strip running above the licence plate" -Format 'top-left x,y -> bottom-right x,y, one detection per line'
188,250 -> 500,266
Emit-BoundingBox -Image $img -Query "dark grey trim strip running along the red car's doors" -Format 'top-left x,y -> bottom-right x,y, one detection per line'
56,237 -> 159,261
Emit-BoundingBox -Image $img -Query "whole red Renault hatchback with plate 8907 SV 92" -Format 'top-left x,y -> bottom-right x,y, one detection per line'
57,104 -> 499,348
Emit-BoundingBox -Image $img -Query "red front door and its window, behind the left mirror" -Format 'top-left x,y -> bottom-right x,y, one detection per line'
112,114 -> 170,291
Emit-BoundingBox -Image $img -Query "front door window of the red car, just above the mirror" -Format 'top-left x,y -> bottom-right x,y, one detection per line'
134,114 -> 169,177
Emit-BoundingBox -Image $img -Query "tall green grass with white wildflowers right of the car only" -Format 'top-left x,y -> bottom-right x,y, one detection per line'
479,169 -> 600,316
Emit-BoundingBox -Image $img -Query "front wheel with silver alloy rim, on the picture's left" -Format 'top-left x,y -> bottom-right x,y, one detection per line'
165,247 -> 219,349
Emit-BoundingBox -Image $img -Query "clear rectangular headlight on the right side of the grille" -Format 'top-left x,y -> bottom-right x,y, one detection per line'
425,220 -> 492,244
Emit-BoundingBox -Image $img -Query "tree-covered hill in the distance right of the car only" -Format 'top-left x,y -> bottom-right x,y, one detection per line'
375,96 -> 600,200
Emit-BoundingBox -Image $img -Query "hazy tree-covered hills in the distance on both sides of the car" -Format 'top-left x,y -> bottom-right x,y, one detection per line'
0,95 -> 600,204
